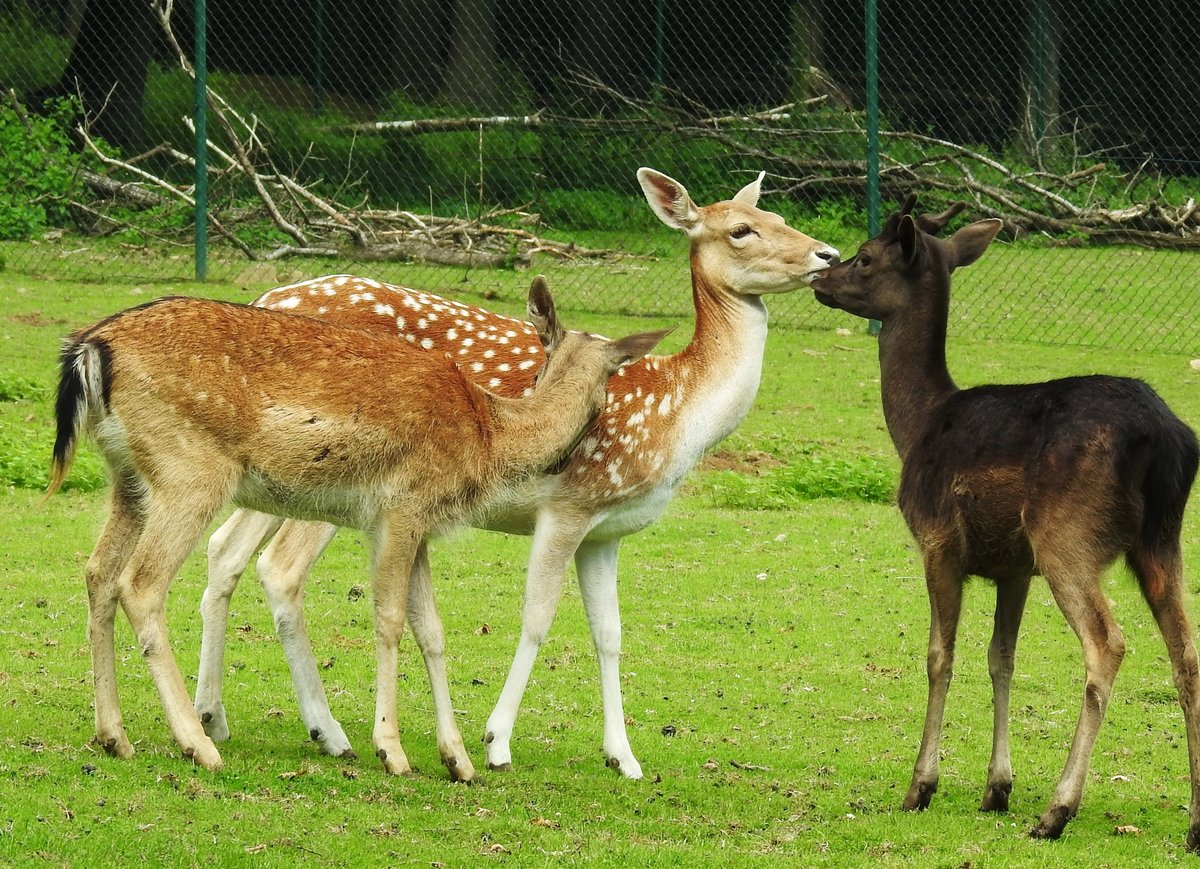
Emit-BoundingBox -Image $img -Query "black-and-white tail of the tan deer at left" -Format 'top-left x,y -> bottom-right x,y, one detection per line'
43,338 -> 109,501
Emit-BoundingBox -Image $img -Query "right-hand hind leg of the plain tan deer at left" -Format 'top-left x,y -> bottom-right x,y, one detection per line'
118,485 -> 226,769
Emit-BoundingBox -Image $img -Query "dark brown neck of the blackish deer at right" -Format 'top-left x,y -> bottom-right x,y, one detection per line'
878,274 -> 958,461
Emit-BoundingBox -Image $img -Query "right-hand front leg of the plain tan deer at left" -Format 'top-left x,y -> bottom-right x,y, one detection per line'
408,540 -> 475,781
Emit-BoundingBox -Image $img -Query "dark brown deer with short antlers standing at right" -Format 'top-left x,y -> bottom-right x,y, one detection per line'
814,198 -> 1200,850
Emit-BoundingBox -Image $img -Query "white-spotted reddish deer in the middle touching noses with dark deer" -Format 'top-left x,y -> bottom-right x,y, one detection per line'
196,168 -> 838,779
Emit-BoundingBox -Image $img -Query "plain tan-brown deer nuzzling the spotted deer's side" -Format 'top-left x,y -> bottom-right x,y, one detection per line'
49,278 -> 662,779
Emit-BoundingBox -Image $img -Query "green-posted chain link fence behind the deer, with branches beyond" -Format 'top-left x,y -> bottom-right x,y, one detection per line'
0,0 -> 1200,352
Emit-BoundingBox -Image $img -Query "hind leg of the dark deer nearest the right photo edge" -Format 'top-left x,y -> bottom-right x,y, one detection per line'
1129,544 -> 1200,851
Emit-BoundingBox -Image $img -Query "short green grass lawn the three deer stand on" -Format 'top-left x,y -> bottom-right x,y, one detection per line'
0,267 -> 1200,868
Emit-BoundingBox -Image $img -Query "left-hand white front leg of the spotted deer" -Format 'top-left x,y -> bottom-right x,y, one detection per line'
484,509 -> 583,769
